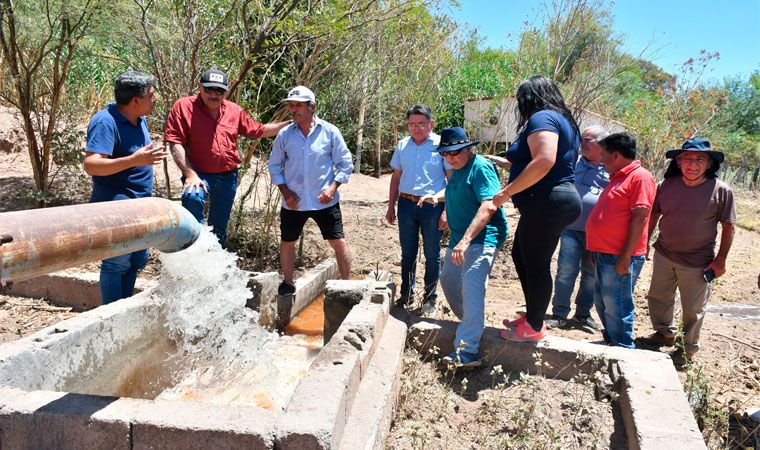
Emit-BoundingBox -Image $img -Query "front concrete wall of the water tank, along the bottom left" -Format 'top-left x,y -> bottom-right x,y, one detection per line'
0,387 -> 281,450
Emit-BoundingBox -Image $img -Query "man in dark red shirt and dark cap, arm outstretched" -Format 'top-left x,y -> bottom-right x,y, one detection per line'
165,69 -> 290,246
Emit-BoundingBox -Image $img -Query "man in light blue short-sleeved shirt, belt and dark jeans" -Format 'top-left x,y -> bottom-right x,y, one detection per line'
385,105 -> 451,315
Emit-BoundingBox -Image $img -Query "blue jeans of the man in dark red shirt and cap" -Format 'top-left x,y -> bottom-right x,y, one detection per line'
182,169 -> 238,247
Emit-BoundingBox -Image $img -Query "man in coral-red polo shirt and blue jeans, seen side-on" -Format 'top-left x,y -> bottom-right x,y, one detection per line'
586,133 -> 657,348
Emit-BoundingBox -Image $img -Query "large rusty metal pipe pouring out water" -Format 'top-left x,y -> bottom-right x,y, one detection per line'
0,198 -> 201,286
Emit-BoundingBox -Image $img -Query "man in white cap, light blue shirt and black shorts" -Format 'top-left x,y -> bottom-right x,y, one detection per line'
269,86 -> 354,295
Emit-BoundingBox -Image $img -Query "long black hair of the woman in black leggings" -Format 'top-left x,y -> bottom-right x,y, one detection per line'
515,76 -> 581,136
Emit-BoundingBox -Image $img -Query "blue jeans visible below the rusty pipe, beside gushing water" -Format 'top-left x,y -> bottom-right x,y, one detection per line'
100,249 -> 148,305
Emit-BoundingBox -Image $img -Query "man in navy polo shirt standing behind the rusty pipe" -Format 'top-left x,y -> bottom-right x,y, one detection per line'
84,71 -> 167,304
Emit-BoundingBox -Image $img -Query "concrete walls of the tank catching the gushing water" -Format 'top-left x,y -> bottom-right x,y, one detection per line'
0,260 -> 407,449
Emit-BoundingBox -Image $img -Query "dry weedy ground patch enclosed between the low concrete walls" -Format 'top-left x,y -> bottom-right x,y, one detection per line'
386,336 -> 616,449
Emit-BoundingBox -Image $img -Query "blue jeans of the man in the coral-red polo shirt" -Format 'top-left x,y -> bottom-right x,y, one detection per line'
593,252 -> 644,348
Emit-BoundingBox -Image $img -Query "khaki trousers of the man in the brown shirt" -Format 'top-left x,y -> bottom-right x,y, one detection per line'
647,250 -> 712,355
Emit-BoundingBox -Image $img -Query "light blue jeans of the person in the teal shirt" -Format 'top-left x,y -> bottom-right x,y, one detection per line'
441,244 -> 496,353
